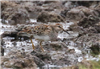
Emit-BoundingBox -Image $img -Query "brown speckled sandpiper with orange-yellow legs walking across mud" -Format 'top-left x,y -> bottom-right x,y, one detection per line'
17,23 -> 69,52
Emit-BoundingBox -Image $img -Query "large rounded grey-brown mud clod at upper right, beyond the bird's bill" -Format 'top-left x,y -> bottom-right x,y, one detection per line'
67,6 -> 98,20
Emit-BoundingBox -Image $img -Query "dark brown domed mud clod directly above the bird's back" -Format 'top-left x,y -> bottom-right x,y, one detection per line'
37,12 -> 65,23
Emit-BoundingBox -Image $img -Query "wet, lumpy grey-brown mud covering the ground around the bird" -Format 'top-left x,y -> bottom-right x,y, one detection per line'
0,0 -> 100,69
